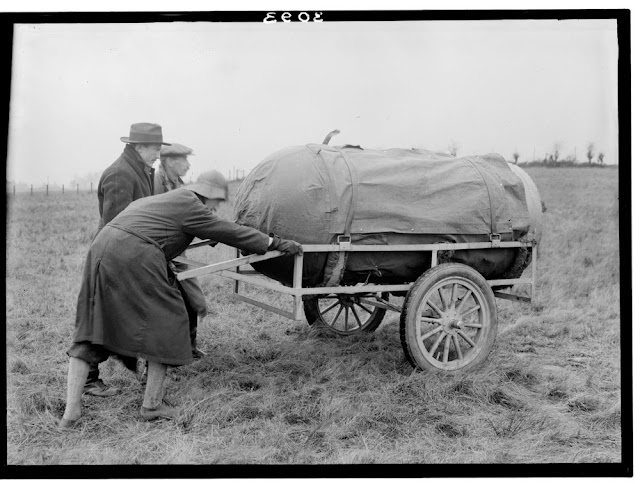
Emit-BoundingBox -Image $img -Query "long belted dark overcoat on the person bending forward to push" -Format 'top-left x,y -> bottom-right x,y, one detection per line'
73,188 -> 269,366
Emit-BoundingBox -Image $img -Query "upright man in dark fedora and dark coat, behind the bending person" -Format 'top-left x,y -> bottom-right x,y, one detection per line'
84,123 -> 169,397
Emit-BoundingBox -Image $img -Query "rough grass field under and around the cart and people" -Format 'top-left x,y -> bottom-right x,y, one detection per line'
6,168 -> 623,474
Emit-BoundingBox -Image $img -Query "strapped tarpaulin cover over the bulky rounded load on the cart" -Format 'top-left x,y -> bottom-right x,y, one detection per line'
235,144 -> 531,285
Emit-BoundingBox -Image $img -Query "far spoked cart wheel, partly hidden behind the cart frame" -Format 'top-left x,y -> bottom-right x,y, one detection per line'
304,292 -> 389,335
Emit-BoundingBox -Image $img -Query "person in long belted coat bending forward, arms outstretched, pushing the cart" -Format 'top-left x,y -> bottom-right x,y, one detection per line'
59,170 -> 302,428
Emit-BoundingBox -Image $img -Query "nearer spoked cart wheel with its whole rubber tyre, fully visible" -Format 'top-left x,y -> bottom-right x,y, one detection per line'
400,263 -> 498,371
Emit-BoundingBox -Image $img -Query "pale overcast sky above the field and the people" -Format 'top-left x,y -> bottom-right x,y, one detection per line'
7,16 -> 618,185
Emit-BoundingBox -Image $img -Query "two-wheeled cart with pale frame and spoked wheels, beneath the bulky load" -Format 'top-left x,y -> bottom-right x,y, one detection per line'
177,239 -> 537,371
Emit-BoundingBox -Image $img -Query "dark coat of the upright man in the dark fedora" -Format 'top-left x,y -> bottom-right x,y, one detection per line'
98,145 -> 154,230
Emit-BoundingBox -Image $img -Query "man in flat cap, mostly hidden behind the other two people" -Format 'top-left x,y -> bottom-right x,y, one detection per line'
153,143 -> 207,359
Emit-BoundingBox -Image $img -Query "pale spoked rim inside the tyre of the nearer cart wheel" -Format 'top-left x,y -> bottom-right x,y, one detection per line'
415,277 -> 492,370
